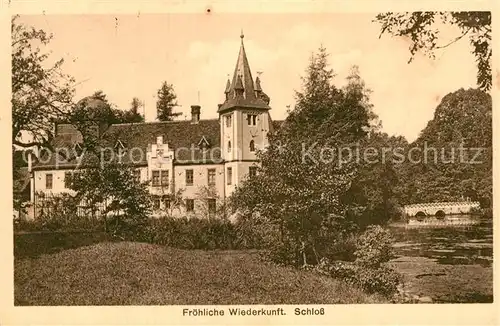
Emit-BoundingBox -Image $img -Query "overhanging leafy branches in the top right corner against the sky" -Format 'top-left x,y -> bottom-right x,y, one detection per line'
375,11 -> 492,90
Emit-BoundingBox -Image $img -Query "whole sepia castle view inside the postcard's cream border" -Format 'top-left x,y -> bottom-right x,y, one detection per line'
7,6 -> 496,317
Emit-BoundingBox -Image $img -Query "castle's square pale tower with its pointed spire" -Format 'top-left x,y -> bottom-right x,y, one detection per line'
217,33 -> 271,195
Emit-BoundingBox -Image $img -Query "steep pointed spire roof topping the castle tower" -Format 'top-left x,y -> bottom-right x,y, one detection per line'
218,33 -> 270,112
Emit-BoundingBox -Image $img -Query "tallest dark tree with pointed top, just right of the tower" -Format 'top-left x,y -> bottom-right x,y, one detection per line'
231,48 -> 376,265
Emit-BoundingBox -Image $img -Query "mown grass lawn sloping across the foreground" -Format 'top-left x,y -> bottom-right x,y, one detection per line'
14,242 -> 384,305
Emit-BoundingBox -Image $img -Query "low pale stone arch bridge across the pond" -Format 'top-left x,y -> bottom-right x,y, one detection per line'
403,201 -> 479,217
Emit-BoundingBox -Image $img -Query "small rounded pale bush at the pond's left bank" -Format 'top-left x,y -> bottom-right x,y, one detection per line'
354,225 -> 393,268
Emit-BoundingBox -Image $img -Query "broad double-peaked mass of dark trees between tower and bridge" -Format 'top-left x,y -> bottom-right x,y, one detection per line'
231,48 -> 397,265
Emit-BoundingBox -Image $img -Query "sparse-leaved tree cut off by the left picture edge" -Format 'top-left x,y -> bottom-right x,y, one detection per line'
11,16 -> 74,148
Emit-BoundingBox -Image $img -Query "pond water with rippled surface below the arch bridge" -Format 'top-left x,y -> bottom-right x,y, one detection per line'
390,215 -> 493,303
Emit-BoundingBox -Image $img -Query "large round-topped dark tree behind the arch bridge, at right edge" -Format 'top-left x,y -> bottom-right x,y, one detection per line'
397,89 -> 493,208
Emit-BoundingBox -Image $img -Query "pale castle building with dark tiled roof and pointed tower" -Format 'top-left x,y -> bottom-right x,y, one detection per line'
29,35 -> 279,215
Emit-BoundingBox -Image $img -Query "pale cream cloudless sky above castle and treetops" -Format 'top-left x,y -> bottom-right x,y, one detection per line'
20,13 -> 476,141
